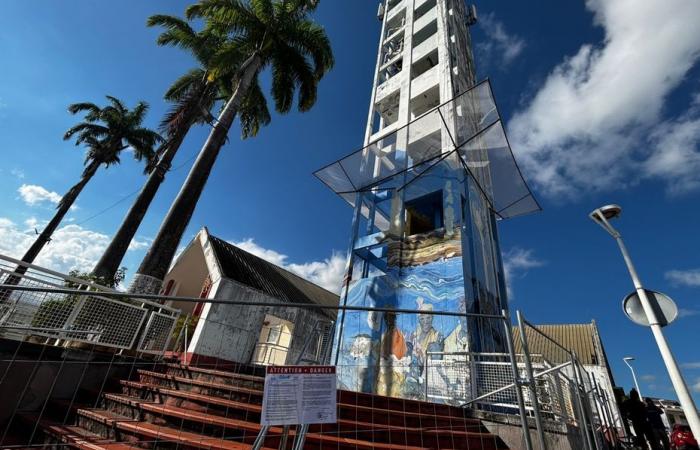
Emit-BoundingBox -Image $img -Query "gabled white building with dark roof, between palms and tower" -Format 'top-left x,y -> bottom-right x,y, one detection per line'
162,228 -> 338,365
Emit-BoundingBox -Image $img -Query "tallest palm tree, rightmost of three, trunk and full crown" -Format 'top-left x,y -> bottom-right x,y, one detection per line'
131,0 -> 334,293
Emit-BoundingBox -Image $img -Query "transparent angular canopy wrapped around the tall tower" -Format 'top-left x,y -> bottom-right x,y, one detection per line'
314,80 -> 541,219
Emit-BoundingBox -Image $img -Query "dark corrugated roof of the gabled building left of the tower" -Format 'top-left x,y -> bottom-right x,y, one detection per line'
209,235 -> 340,315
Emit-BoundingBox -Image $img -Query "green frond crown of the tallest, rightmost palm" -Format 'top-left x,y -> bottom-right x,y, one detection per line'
186,0 -> 334,119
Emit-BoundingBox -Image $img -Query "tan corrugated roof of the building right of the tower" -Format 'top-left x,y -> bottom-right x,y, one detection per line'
513,323 -> 605,365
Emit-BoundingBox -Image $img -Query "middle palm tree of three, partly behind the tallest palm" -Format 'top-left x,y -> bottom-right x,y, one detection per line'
92,15 -> 270,279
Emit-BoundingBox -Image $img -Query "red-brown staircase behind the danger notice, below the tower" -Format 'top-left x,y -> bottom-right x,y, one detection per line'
35,364 -> 507,450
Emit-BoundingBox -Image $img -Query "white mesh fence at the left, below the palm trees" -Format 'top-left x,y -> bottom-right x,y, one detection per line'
0,255 -> 180,355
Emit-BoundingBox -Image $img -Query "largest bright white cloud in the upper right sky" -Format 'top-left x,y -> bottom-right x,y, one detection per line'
510,0 -> 700,196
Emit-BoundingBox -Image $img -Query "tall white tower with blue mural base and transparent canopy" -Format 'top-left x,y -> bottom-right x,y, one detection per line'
316,0 -> 539,400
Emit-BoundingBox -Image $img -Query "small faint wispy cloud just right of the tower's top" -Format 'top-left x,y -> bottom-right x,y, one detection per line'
476,13 -> 525,67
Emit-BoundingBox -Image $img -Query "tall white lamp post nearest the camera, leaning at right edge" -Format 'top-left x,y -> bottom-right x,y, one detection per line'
590,205 -> 700,436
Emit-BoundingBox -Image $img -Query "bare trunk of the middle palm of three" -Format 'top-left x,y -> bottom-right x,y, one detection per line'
92,123 -> 192,280
